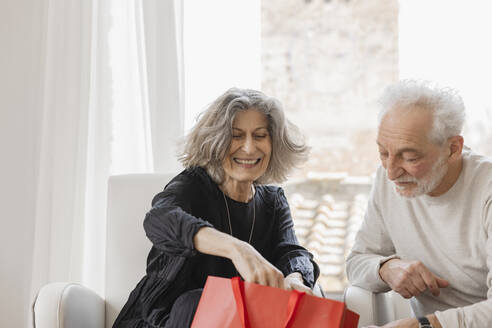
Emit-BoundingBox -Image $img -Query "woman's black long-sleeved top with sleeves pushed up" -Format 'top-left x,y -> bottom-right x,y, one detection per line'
113,167 -> 319,327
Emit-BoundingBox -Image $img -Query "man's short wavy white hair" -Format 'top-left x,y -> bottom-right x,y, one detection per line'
378,80 -> 465,145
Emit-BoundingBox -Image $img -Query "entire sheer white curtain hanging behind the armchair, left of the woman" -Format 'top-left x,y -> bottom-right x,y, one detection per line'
29,0 -> 183,324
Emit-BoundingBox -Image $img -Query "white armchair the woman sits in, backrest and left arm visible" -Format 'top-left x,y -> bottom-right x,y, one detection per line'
34,174 -> 176,328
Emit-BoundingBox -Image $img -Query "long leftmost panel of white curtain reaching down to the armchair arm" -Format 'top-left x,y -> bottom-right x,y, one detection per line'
31,0 -> 98,308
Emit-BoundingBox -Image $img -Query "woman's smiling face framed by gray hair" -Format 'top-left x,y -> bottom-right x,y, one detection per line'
222,109 -> 272,183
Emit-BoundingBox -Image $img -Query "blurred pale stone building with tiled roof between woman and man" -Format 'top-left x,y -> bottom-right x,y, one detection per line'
261,0 -> 398,292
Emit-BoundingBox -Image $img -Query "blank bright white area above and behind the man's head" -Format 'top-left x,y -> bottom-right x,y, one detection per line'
399,0 -> 492,146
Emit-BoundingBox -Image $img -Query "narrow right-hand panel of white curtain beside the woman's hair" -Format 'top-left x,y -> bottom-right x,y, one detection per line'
143,0 -> 184,173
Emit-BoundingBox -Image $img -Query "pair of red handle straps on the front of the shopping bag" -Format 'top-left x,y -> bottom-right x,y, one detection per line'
231,277 -> 305,328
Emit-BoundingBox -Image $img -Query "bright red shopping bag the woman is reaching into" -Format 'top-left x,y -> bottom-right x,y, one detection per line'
191,276 -> 359,328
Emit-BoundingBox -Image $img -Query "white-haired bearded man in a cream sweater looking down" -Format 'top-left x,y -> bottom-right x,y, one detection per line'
347,80 -> 492,328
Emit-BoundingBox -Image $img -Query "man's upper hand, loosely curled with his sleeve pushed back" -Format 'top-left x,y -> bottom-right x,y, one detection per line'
379,259 -> 449,298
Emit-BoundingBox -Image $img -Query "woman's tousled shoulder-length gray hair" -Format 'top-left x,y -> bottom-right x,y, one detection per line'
178,88 -> 309,184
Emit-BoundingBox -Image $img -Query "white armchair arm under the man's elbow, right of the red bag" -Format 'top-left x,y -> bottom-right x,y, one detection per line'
344,286 -> 413,327
